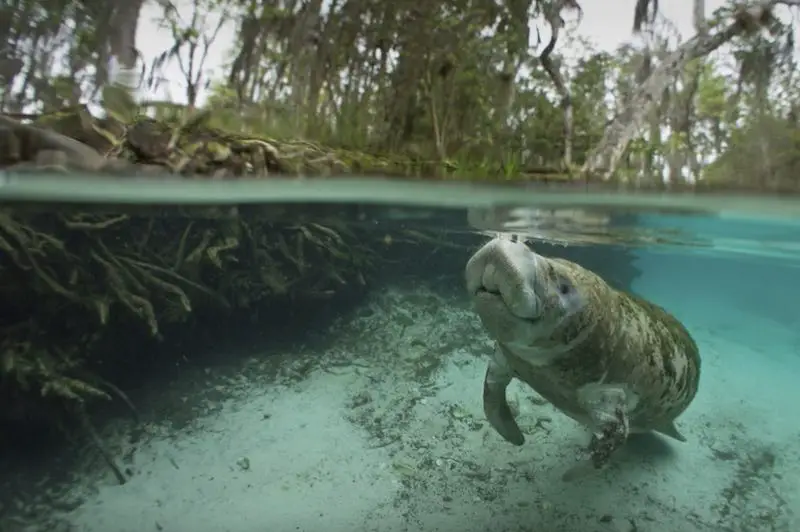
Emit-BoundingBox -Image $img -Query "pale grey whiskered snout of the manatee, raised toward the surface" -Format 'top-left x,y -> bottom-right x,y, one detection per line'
466,238 -> 542,320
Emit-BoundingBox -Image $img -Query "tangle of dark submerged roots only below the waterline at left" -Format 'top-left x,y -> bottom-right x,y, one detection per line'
0,204 -> 388,440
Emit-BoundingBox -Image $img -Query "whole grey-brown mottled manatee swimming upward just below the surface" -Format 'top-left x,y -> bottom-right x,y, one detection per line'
466,238 -> 700,480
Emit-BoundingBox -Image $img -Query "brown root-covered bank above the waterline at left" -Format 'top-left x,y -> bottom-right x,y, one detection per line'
0,107 -> 434,178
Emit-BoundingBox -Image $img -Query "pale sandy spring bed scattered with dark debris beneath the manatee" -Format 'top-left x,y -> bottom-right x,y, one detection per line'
1,287 -> 800,532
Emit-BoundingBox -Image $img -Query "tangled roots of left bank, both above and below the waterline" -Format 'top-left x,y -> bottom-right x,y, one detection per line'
0,109 -> 456,484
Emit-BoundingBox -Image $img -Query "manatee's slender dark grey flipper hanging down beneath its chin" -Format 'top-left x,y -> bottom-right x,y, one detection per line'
483,347 -> 525,445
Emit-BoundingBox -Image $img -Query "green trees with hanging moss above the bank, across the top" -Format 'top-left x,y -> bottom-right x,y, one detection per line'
0,0 -> 800,190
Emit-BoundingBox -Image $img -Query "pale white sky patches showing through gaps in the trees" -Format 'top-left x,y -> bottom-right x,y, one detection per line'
136,0 -> 724,105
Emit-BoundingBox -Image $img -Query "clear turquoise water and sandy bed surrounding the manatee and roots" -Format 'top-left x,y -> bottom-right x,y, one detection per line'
0,178 -> 800,532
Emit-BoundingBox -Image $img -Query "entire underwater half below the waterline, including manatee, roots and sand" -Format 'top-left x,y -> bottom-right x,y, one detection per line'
0,176 -> 800,532
